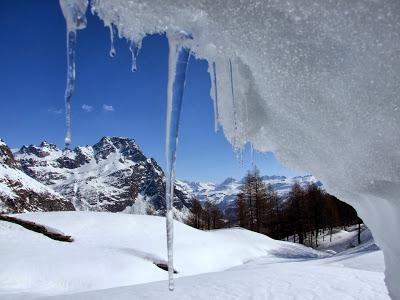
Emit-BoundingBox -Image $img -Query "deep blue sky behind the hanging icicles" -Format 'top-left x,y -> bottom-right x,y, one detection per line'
0,0 -> 306,182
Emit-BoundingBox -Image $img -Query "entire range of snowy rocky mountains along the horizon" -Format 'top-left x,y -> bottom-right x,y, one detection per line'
0,137 -> 321,219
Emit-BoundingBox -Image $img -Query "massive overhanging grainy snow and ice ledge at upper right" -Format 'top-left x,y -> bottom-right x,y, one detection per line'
60,0 -> 400,299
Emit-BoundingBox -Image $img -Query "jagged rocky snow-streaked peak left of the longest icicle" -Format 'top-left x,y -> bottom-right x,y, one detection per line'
15,137 -> 189,215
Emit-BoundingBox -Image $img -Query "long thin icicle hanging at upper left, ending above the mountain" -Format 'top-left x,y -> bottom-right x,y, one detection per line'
60,0 -> 88,147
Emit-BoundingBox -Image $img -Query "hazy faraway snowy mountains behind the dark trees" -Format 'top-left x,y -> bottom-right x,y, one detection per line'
176,175 -> 322,214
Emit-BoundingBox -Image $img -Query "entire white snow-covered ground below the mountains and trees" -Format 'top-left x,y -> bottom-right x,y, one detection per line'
0,212 -> 389,299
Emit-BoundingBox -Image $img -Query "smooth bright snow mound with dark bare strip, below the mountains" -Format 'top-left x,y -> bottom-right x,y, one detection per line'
0,212 -> 326,299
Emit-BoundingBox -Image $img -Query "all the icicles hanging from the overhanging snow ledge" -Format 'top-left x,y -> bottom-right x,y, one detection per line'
60,0 -> 237,291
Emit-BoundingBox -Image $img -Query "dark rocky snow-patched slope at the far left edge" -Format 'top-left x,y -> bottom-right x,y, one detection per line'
0,139 -> 75,213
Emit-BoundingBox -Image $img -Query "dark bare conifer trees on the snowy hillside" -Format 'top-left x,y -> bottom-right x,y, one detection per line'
186,168 -> 362,247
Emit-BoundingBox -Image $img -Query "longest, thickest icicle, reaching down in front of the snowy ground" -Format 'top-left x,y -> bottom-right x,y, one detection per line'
165,32 -> 190,291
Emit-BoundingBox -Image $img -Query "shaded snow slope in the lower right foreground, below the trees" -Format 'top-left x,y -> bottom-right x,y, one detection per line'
37,221 -> 390,300
